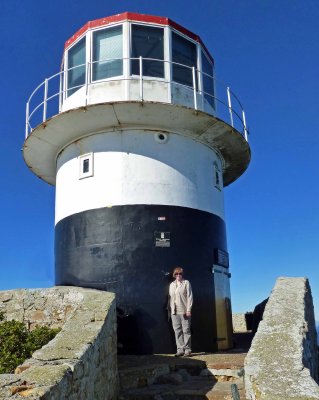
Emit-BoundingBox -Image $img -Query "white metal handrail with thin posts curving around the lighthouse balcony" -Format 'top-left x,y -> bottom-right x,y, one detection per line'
25,57 -> 249,140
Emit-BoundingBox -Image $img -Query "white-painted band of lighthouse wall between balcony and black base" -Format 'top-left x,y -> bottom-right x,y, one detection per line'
55,130 -> 224,223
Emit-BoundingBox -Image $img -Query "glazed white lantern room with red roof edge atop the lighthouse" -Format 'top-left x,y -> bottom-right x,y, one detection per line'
61,12 -> 216,114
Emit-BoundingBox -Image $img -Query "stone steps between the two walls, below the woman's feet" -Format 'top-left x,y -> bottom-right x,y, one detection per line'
118,352 -> 246,400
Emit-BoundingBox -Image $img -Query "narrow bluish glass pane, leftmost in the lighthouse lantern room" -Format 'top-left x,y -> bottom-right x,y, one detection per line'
67,37 -> 86,96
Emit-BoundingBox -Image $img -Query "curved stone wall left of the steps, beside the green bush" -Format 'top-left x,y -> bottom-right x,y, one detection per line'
0,287 -> 118,400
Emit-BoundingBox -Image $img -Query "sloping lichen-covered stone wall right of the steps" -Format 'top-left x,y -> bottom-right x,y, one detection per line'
245,278 -> 319,400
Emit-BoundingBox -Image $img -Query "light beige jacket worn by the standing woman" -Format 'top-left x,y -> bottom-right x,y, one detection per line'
169,279 -> 193,314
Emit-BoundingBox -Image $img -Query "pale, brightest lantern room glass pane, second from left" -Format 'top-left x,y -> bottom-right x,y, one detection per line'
93,25 -> 123,81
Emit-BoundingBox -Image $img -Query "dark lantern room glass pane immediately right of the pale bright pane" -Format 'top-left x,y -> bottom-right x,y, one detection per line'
131,24 -> 164,78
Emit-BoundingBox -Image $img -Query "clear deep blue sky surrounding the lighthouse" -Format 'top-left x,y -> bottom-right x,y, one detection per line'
0,0 -> 319,319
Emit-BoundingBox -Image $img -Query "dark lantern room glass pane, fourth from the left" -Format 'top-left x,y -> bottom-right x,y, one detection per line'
172,32 -> 197,87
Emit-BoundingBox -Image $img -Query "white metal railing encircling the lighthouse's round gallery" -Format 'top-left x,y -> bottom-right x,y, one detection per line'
25,57 -> 248,141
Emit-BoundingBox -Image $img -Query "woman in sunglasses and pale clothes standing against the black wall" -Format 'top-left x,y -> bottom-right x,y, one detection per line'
169,267 -> 193,357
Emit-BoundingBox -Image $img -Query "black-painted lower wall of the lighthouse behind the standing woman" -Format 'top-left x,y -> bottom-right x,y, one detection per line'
55,205 -> 226,354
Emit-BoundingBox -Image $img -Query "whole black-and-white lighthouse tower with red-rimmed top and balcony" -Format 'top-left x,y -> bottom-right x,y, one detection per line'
23,13 -> 250,354
